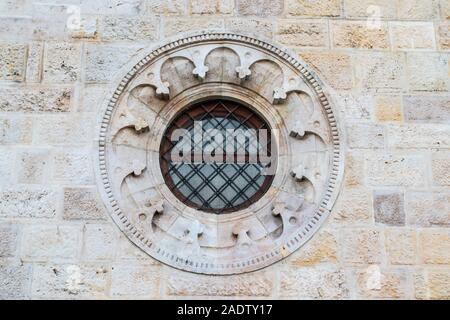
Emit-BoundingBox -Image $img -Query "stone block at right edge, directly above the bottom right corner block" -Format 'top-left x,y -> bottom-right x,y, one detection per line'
419,229 -> 450,265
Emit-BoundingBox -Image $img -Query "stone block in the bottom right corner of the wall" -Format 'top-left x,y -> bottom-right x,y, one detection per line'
414,269 -> 450,300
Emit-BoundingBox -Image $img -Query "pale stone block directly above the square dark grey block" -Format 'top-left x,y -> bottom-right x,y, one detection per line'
366,153 -> 425,186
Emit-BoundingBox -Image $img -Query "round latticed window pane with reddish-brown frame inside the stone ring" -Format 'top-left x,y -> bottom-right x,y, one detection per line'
160,100 -> 273,214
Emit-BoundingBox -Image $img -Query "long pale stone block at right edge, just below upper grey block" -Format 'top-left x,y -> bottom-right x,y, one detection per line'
386,124 -> 450,148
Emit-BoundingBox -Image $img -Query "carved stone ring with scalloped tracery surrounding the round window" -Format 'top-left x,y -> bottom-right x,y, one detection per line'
96,32 -> 343,274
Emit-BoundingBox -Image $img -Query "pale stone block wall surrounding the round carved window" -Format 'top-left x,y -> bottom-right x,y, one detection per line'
0,0 -> 450,299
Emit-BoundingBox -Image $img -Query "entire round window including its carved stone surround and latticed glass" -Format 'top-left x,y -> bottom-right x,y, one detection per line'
96,32 -> 343,274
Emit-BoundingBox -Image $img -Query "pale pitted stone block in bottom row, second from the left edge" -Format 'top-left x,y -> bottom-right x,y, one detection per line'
31,263 -> 110,299
